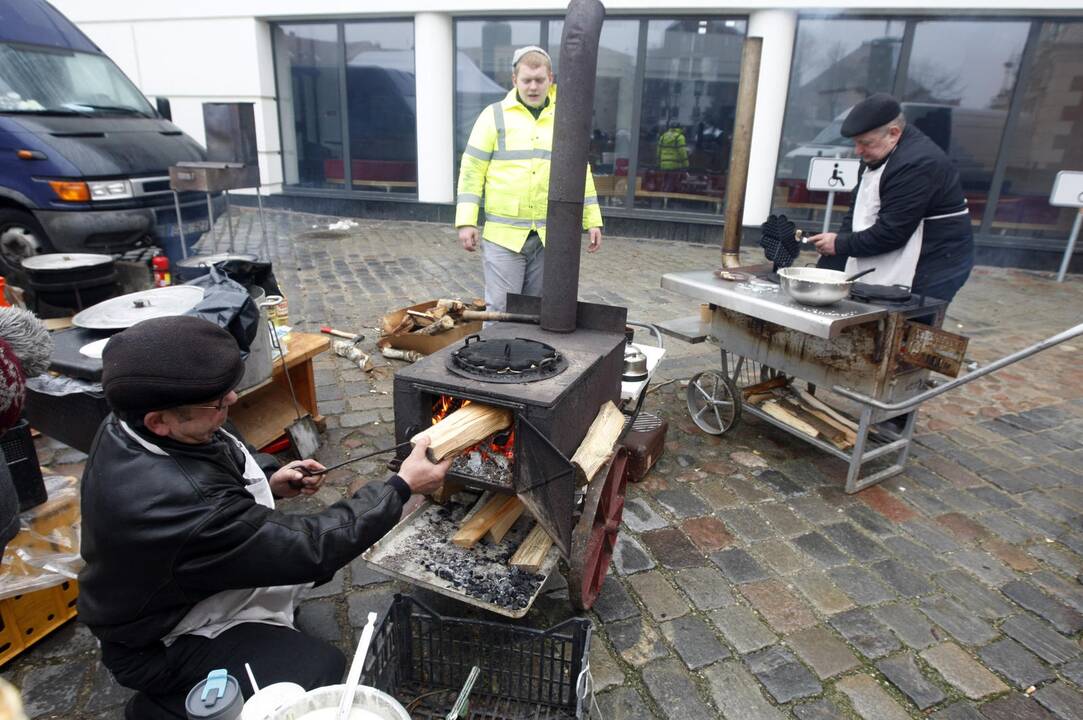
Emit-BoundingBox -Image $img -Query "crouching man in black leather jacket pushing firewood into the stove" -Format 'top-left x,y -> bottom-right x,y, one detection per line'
79,317 -> 448,719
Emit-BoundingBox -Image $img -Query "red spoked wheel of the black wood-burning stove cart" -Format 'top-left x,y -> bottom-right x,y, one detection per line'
567,446 -> 628,610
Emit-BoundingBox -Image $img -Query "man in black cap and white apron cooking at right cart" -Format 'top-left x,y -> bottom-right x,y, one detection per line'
811,93 -> 974,301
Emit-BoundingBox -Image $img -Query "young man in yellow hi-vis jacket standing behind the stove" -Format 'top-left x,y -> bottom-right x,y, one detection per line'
455,45 -> 602,312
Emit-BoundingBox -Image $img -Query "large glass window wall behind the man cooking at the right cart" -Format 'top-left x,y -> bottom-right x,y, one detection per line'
772,16 -> 1083,255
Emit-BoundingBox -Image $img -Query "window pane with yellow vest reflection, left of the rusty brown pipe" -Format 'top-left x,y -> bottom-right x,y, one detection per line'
636,18 -> 745,212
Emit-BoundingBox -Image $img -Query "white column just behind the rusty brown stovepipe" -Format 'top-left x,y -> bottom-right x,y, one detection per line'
742,10 -> 797,226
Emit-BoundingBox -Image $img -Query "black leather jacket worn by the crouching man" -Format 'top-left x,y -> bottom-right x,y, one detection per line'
78,416 -> 409,649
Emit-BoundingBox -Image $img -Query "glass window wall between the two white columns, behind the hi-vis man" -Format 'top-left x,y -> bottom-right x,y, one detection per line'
455,17 -> 745,212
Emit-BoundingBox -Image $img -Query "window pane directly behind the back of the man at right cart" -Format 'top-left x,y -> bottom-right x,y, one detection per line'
901,21 -> 1030,225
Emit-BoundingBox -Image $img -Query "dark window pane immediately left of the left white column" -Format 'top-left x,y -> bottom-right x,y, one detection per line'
344,22 -> 417,193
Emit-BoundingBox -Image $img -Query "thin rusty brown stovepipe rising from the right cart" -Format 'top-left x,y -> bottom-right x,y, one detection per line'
719,38 -> 764,267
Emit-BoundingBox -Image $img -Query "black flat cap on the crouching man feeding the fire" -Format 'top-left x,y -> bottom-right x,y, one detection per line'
102,315 -> 245,418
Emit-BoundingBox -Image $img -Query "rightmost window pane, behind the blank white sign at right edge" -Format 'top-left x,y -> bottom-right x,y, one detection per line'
991,22 -> 1083,240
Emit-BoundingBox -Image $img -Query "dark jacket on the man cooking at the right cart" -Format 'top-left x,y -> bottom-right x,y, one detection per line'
835,126 -> 974,292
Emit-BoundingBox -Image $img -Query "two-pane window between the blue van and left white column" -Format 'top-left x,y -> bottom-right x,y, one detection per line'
274,21 -> 417,193
